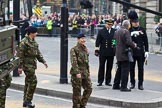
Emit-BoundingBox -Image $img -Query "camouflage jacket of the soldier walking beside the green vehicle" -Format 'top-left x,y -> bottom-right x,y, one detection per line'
18,36 -> 45,69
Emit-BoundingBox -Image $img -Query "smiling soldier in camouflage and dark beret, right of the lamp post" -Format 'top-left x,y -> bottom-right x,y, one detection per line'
70,34 -> 92,108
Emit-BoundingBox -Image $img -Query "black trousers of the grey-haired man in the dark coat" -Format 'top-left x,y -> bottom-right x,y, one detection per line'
113,61 -> 130,89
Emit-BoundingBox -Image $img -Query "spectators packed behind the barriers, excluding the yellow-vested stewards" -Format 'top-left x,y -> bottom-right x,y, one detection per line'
26,12 -> 125,27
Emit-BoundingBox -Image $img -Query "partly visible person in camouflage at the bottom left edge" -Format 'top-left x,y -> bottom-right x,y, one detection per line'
0,74 -> 12,108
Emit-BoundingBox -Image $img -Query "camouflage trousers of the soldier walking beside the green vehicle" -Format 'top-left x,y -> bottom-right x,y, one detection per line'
24,68 -> 37,102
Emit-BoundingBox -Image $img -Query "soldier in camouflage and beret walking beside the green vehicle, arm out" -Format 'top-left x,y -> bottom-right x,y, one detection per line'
18,26 -> 48,108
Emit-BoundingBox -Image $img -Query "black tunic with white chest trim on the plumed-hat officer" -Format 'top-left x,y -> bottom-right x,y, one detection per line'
129,27 -> 149,56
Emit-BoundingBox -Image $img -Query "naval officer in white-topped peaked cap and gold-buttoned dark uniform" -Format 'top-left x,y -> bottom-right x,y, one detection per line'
95,19 -> 115,86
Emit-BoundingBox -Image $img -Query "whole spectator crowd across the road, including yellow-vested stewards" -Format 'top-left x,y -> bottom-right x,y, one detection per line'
17,12 -> 125,36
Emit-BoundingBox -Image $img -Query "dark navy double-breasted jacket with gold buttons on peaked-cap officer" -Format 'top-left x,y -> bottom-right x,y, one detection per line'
95,27 -> 115,56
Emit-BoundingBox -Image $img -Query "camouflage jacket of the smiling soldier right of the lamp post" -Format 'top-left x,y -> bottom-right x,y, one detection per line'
70,43 -> 89,78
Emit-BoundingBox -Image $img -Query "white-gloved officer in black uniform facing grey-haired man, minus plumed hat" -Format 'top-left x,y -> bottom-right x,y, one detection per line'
129,18 -> 149,90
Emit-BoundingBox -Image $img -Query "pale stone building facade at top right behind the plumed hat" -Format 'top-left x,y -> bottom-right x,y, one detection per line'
113,0 -> 162,32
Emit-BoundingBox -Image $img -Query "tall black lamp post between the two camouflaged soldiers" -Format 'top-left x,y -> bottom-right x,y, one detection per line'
60,0 -> 68,84
